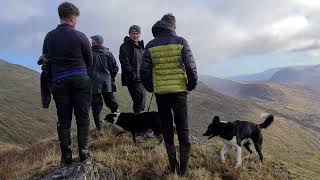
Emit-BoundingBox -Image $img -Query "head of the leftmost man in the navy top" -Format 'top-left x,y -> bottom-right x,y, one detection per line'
58,2 -> 80,27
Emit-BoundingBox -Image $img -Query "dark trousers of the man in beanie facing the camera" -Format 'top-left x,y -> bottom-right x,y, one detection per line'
127,82 -> 146,113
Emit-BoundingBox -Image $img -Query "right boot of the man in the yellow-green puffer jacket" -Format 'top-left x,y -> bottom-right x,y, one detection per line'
178,143 -> 191,176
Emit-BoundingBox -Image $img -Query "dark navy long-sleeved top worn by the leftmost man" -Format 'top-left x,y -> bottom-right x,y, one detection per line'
42,24 -> 92,78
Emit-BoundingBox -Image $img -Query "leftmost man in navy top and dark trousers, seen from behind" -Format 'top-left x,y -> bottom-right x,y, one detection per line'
42,2 -> 92,164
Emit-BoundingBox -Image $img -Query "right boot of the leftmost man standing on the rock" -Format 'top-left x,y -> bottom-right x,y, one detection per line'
77,126 -> 90,162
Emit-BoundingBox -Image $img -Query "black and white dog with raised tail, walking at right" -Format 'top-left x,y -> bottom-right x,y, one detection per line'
203,115 -> 274,168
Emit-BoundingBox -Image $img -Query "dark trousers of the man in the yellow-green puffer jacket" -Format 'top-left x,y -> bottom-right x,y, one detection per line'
155,93 -> 189,145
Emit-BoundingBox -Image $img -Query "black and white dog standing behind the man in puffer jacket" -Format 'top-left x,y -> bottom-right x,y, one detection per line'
105,112 -> 162,143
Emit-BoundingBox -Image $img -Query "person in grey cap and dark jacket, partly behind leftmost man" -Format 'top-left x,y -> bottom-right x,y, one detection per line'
88,35 -> 119,130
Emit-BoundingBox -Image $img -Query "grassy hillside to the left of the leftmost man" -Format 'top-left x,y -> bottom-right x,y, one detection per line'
0,60 -> 55,144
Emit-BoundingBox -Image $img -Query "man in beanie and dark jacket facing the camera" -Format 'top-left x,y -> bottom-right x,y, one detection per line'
119,25 -> 146,113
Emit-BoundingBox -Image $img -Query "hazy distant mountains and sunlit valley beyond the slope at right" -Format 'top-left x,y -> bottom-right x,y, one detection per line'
200,65 -> 320,132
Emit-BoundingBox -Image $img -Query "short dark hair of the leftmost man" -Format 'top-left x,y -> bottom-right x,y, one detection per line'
58,2 -> 80,20
